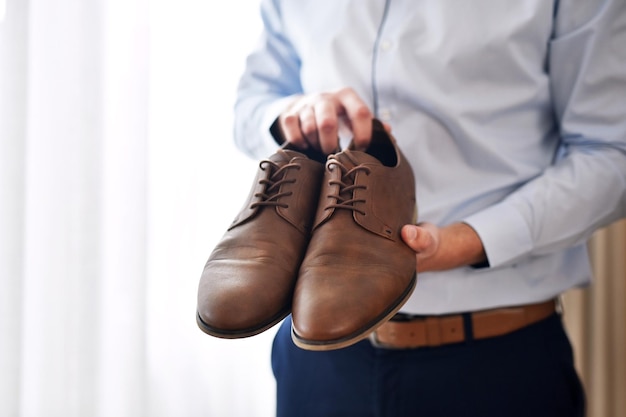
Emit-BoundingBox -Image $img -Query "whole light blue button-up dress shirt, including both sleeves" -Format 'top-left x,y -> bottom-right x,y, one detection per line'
235,0 -> 626,314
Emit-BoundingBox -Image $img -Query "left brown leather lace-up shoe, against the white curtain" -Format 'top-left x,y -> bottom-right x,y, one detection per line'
197,144 -> 326,338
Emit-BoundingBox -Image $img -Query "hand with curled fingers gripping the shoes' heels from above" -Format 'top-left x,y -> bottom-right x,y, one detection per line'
278,88 -> 373,154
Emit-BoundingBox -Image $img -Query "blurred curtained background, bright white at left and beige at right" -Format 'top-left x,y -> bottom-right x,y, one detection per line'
0,0 -> 626,417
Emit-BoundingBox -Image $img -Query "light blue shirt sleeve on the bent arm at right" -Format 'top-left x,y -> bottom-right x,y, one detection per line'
464,0 -> 626,267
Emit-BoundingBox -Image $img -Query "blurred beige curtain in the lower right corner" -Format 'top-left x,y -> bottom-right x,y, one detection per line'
564,220 -> 626,417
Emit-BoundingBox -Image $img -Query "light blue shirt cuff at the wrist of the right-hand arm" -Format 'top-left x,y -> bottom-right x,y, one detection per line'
463,203 -> 533,268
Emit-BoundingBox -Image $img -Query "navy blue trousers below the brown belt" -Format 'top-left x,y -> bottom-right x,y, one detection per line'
272,314 -> 585,417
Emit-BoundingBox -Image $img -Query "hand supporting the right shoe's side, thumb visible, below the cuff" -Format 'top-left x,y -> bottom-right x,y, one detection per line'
402,223 -> 487,272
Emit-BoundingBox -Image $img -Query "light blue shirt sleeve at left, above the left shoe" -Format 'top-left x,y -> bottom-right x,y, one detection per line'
234,0 -> 302,158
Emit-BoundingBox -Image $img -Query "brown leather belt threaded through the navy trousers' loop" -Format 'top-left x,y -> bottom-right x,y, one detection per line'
370,299 -> 559,349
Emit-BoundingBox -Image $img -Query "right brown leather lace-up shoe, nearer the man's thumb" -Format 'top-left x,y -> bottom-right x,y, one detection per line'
292,120 -> 416,350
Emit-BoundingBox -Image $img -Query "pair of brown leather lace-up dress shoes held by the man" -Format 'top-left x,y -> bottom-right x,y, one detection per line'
197,120 -> 416,350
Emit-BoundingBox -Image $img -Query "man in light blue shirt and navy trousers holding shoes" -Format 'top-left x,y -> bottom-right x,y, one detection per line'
229,0 -> 626,417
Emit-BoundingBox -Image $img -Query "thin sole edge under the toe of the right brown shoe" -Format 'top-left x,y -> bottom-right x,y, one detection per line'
291,273 -> 417,351
